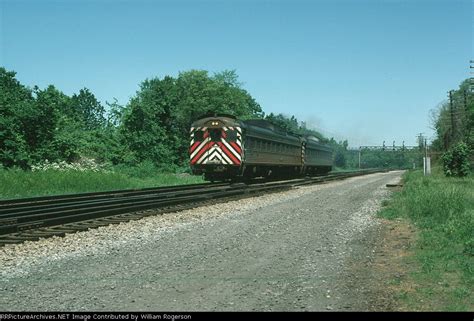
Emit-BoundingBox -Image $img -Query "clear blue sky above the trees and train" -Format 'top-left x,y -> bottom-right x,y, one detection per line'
0,0 -> 473,146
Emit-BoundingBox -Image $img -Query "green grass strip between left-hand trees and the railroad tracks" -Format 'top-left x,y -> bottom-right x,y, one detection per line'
0,167 -> 204,199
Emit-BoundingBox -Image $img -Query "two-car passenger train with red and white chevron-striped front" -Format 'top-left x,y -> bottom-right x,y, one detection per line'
189,114 -> 333,181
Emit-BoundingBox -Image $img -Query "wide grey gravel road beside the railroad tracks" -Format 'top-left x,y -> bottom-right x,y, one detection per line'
0,171 -> 402,311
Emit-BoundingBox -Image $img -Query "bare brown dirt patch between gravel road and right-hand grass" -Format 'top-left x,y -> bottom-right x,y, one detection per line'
341,215 -> 416,311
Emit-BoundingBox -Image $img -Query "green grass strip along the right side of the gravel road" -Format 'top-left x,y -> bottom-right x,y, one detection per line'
380,169 -> 474,311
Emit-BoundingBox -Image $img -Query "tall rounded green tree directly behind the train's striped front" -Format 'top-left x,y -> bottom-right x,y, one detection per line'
120,70 -> 262,167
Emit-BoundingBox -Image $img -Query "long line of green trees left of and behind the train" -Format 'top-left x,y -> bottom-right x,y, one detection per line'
0,68 -> 347,170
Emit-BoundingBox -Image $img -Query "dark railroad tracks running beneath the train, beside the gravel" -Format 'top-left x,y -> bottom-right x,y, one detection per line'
0,170 -> 383,246
